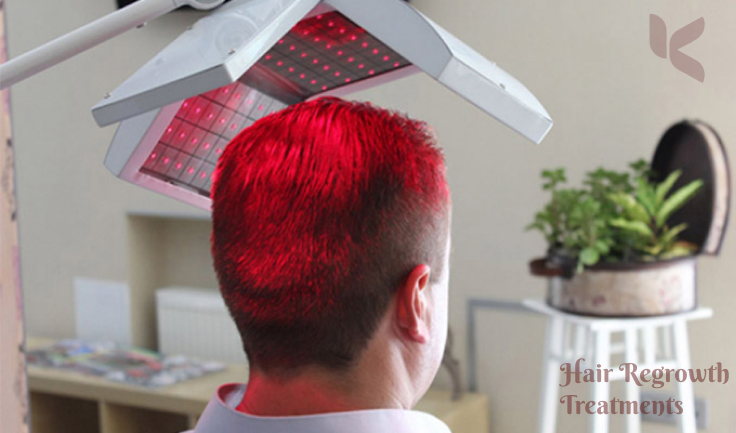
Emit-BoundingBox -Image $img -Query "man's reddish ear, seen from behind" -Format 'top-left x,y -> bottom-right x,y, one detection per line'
396,265 -> 430,343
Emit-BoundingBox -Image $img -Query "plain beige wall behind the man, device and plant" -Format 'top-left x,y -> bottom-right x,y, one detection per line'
7,0 -> 736,432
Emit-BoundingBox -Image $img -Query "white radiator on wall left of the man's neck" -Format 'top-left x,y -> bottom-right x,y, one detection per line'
156,287 -> 246,363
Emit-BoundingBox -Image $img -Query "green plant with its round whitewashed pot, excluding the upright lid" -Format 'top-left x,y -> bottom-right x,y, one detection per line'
528,160 -> 703,316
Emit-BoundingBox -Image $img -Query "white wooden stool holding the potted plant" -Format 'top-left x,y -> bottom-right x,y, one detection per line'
523,299 -> 713,433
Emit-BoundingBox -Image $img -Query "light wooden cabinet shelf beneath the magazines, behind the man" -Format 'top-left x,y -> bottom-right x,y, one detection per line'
26,338 -> 488,433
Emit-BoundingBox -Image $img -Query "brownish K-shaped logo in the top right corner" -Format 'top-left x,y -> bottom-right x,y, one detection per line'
649,14 -> 705,83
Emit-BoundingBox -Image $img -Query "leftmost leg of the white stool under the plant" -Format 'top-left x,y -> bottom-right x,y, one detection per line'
537,318 -> 565,433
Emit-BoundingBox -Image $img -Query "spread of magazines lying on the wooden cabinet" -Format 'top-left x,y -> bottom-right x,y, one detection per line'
27,340 -> 225,388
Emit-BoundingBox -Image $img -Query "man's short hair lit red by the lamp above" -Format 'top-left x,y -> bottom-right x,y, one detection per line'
212,98 -> 450,373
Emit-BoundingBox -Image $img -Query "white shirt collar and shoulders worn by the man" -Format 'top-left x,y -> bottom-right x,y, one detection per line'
193,384 -> 451,433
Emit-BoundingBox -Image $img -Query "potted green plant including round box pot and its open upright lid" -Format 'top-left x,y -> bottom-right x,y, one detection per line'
528,120 -> 731,316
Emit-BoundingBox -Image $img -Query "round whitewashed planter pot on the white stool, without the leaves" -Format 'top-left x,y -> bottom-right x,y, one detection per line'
530,257 -> 697,316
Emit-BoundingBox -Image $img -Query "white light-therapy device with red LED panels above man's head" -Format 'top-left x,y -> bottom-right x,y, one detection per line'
93,0 -> 552,209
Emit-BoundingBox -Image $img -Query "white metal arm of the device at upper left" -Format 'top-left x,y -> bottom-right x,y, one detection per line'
0,0 -> 224,89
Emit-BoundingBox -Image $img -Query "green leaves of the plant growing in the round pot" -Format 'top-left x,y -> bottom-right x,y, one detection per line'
527,160 -> 703,271
